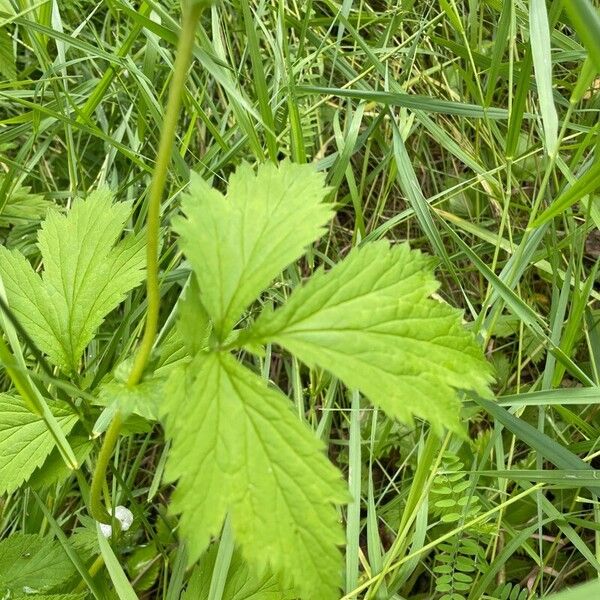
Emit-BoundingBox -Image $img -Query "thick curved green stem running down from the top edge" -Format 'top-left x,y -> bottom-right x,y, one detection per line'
90,2 -> 206,523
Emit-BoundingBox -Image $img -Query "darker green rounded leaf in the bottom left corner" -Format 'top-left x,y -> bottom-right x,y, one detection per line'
0,533 -> 75,597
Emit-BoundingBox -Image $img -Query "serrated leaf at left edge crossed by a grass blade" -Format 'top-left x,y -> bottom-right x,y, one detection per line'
0,394 -> 77,495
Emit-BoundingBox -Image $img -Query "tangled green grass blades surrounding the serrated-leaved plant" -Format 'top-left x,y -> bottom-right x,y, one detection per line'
0,0 -> 600,600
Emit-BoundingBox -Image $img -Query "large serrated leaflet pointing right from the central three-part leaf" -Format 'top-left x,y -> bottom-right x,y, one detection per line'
240,241 -> 491,432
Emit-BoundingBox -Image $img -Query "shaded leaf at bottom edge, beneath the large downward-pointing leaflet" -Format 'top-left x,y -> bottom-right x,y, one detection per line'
182,544 -> 296,600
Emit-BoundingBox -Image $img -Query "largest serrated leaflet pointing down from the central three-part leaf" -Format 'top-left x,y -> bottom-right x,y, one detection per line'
164,352 -> 346,600
